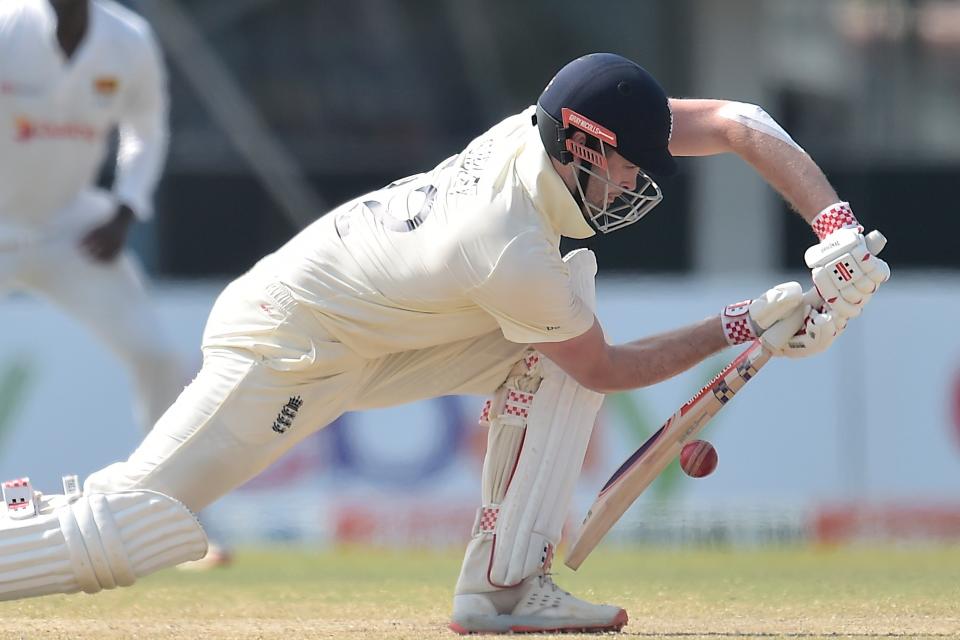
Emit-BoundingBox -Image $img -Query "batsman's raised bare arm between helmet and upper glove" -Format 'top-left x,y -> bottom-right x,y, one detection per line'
670,98 -> 840,222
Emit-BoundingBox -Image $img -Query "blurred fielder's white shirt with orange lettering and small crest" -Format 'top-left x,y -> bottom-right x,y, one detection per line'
0,0 -> 167,230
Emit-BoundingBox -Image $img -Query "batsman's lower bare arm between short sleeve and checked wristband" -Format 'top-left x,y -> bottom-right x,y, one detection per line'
533,316 -> 728,393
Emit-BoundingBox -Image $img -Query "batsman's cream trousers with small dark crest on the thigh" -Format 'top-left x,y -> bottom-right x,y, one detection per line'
84,274 -> 526,512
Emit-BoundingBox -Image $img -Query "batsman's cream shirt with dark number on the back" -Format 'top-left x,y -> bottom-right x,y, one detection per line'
253,107 -> 593,358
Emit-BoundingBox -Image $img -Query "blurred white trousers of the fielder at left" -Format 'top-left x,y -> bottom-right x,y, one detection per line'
0,190 -> 190,431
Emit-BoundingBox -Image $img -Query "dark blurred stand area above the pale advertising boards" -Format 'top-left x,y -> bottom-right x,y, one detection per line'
129,0 -> 960,278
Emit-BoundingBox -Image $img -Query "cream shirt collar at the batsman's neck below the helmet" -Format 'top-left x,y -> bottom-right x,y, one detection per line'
516,107 -> 596,239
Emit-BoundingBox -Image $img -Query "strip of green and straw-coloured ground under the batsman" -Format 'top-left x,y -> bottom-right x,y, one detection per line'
0,547 -> 960,640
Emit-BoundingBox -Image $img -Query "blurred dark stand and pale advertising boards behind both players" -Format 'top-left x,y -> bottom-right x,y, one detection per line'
0,0 -> 960,545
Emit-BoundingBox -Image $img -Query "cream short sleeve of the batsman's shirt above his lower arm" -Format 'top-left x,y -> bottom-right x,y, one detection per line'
472,232 -> 594,344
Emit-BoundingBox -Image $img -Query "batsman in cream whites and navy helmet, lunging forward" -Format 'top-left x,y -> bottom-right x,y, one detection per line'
0,54 -> 889,633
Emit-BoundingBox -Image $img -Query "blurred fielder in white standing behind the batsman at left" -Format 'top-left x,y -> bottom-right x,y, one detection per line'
0,0 -> 232,560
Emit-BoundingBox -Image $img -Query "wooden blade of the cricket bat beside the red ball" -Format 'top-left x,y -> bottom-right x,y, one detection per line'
566,341 -> 770,569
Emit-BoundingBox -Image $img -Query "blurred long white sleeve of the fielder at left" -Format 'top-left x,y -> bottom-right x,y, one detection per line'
113,25 -> 169,220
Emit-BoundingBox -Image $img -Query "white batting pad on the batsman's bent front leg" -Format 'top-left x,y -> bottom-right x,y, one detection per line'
487,249 -> 604,586
